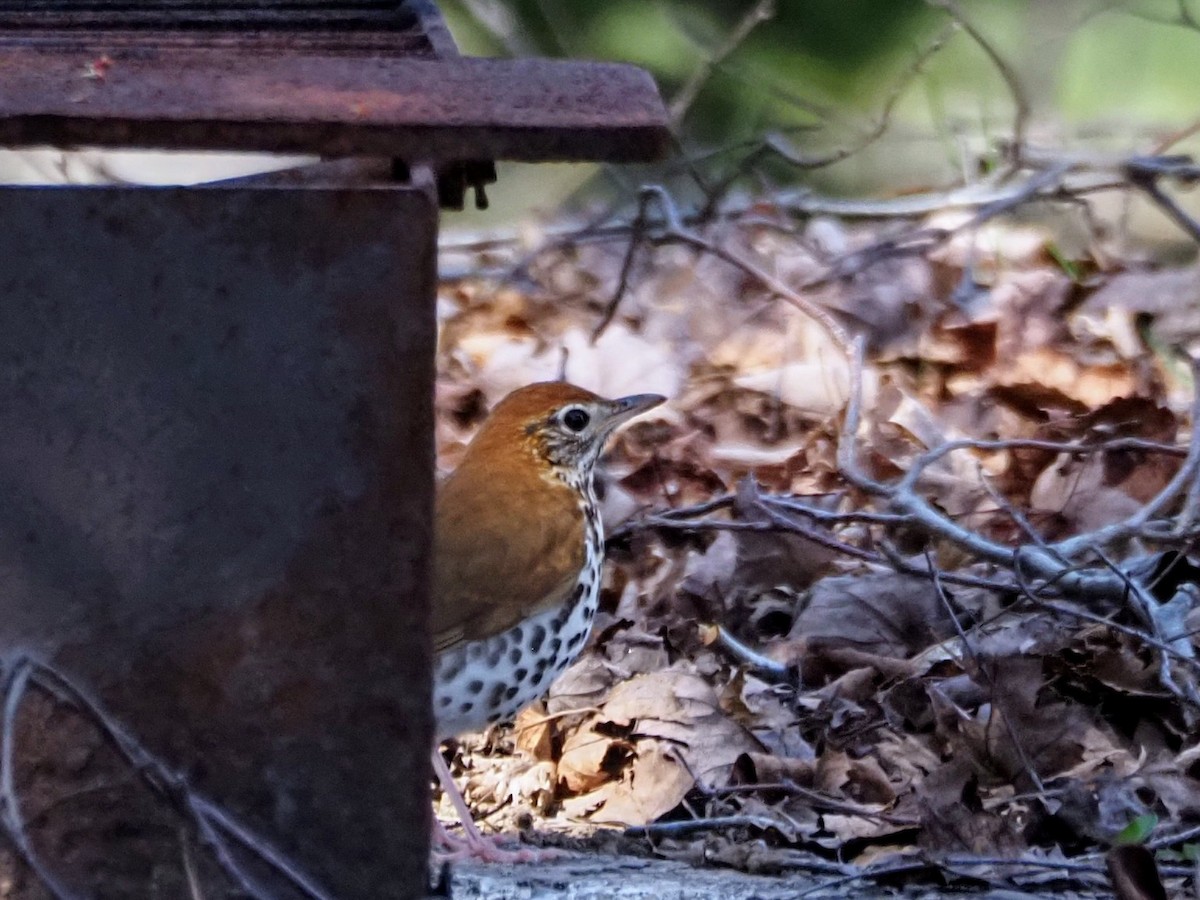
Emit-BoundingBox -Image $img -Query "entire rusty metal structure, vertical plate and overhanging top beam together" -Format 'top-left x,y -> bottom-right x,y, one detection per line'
0,0 -> 668,899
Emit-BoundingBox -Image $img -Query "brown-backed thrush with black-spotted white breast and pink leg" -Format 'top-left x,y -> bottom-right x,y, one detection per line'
430,382 -> 666,862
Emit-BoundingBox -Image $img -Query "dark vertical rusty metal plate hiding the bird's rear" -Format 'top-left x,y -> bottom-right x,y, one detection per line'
0,187 -> 437,899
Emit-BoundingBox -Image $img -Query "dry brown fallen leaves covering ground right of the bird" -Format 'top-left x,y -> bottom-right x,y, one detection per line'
438,207 -> 1200,893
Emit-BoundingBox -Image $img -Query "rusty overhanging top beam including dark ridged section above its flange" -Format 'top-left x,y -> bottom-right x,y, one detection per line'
0,0 -> 671,168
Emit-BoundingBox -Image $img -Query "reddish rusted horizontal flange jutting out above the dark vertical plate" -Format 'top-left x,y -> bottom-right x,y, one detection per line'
0,49 -> 671,164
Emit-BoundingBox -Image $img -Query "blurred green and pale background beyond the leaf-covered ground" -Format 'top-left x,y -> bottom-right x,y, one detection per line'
439,0 -> 1200,238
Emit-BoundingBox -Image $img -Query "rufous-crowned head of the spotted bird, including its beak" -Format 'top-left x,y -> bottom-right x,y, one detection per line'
472,382 -> 666,473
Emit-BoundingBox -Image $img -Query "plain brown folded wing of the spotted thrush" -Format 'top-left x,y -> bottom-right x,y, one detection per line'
431,458 -> 584,653
